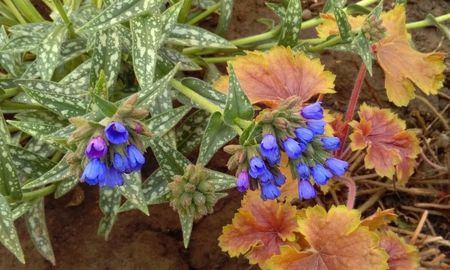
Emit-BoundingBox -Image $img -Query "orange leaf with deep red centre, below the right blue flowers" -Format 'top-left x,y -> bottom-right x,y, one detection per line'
219,191 -> 298,266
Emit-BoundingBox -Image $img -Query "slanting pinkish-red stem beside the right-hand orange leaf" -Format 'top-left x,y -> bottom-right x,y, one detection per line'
337,63 -> 366,157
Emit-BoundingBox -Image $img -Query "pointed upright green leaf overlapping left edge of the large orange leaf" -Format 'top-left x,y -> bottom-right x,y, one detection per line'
223,65 -> 253,126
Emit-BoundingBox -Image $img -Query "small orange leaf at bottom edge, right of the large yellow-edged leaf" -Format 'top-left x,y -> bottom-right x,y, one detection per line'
380,231 -> 419,270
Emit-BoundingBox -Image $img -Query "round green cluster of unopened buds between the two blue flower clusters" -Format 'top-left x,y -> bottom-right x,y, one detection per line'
169,164 -> 219,219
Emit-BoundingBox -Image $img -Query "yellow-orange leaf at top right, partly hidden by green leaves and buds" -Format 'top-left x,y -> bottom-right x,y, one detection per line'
317,5 -> 445,106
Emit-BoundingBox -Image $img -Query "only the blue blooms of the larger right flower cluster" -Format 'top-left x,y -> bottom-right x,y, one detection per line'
237,102 -> 348,200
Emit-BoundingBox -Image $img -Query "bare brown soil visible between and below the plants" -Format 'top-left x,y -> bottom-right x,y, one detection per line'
0,0 -> 450,270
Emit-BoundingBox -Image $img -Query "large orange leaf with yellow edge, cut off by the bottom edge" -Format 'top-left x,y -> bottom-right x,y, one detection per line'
267,205 -> 388,270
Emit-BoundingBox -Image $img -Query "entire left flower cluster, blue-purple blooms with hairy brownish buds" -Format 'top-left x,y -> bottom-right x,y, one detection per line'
67,96 -> 149,188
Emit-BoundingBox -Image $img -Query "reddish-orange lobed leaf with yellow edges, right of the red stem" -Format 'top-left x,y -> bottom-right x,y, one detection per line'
350,104 -> 420,184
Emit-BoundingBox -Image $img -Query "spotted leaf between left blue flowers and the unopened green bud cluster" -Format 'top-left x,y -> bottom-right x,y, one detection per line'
119,169 -> 169,212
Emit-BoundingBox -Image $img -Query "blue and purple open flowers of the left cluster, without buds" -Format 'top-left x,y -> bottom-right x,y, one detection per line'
81,122 -> 145,188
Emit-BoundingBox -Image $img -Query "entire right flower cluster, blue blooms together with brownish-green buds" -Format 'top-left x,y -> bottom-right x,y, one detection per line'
225,99 -> 348,200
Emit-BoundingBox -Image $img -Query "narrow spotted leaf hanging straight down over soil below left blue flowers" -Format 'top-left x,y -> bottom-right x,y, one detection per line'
97,188 -> 122,240
